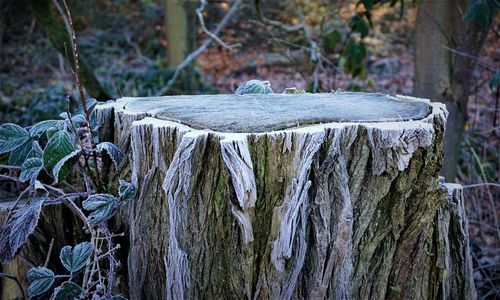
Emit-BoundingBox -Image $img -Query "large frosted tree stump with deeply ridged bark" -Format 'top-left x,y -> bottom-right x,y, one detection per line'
96,93 -> 475,299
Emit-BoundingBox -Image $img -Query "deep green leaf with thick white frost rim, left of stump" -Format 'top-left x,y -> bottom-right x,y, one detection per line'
43,130 -> 75,174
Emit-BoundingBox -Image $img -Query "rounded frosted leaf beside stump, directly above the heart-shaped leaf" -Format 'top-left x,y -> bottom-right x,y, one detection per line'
82,194 -> 116,225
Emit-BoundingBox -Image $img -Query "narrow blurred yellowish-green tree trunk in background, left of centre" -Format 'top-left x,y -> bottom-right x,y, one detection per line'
164,0 -> 199,92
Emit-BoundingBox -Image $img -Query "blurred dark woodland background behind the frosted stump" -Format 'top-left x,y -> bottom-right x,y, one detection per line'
0,0 -> 500,299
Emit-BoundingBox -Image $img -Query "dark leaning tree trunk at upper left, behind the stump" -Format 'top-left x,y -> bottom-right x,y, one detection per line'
30,0 -> 111,101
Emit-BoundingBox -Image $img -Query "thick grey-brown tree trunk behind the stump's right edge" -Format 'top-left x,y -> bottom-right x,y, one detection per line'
414,0 -> 494,181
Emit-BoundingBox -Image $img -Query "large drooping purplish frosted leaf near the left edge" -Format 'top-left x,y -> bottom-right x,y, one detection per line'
9,197 -> 47,254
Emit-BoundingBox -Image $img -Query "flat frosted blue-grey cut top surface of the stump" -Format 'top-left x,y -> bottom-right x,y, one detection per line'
119,92 -> 431,133
